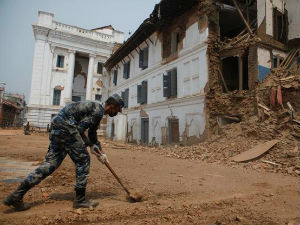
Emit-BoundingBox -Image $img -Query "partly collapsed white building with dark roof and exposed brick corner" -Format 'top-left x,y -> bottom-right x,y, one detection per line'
105,0 -> 300,144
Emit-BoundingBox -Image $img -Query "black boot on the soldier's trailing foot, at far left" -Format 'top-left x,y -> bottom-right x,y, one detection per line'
3,182 -> 31,211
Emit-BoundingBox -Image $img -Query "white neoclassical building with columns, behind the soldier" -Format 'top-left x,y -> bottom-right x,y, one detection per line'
27,11 -> 124,127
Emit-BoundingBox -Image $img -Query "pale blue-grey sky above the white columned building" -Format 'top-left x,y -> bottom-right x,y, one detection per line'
0,0 -> 159,102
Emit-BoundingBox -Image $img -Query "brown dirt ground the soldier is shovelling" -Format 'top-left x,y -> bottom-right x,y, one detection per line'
0,131 -> 300,225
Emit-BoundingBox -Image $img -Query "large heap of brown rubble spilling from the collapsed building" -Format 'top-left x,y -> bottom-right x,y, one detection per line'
122,50 -> 300,176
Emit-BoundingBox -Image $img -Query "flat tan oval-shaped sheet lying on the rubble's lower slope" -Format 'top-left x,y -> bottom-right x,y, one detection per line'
231,140 -> 278,162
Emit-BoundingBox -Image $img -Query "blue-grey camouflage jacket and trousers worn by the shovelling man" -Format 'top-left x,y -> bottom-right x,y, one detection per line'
24,102 -> 104,188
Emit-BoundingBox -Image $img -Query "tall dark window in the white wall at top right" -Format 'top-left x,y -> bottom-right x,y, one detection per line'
273,8 -> 288,43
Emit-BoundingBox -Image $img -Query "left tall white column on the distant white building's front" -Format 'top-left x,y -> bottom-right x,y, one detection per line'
65,50 -> 75,103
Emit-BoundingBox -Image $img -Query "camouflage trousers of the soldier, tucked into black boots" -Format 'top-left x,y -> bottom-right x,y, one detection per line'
24,127 -> 90,188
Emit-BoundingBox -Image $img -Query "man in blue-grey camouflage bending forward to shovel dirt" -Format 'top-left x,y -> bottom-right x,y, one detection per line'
3,94 -> 124,211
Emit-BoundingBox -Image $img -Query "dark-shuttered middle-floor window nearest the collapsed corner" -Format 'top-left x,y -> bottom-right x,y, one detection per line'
163,68 -> 177,98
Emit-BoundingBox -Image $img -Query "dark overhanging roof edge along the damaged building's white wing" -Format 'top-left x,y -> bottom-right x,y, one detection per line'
104,0 -> 200,70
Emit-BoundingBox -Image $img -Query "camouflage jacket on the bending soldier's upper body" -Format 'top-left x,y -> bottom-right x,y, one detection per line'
52,101 -> 104,148
